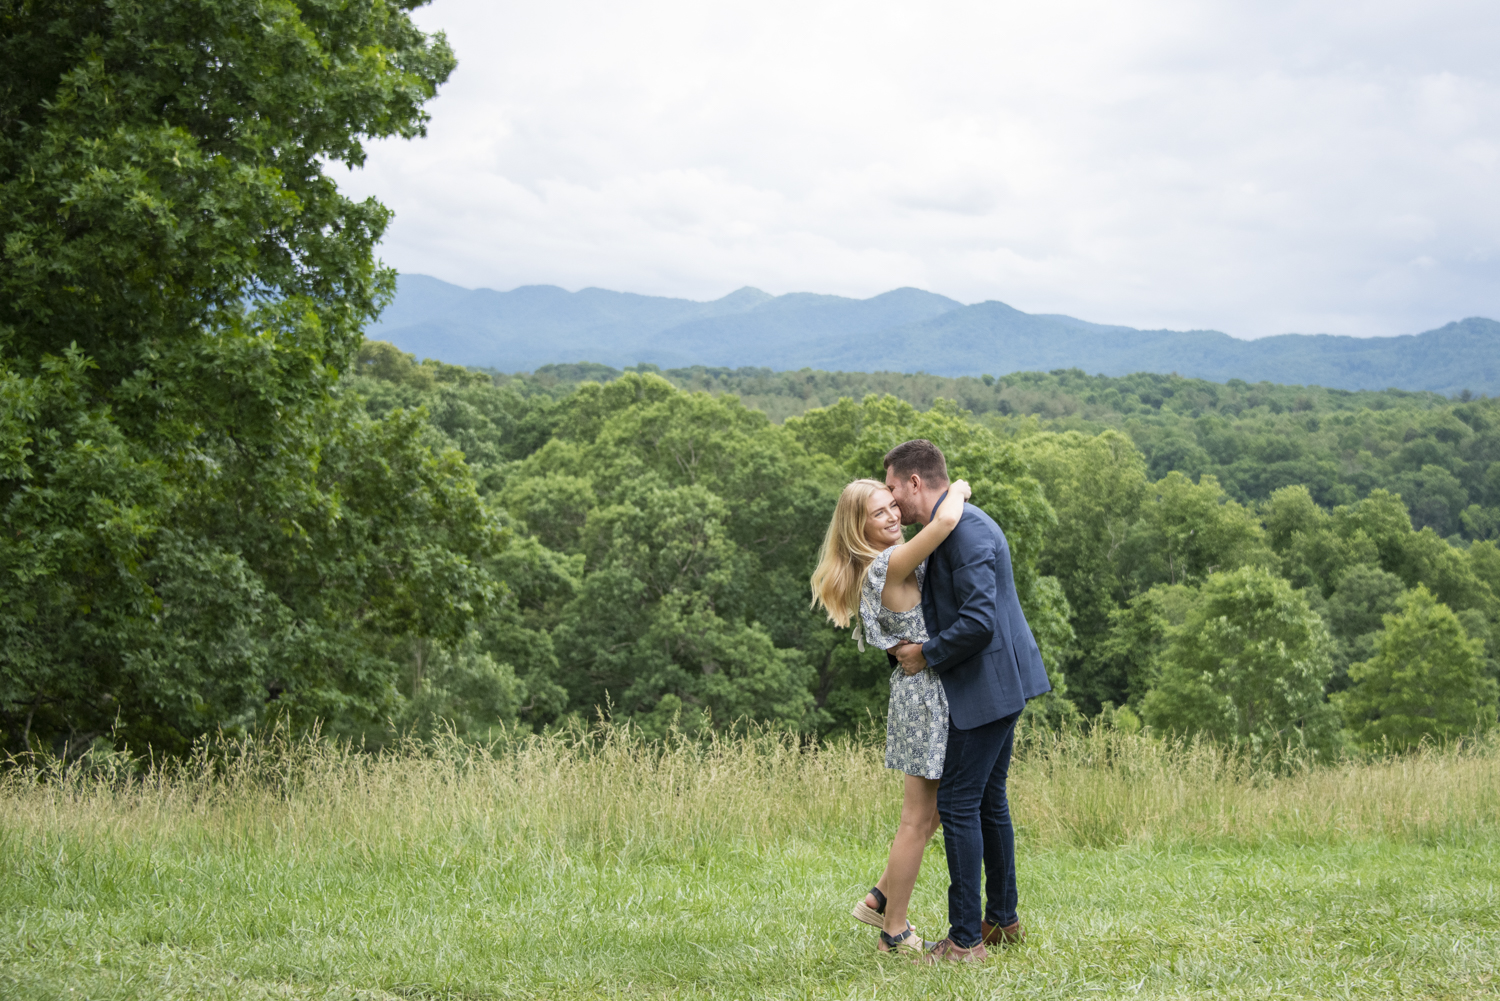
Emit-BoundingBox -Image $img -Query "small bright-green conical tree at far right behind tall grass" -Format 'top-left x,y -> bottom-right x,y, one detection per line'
1335,584 -> 1496,750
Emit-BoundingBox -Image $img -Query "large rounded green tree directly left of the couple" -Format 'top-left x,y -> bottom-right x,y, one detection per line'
501,374 -> 840,729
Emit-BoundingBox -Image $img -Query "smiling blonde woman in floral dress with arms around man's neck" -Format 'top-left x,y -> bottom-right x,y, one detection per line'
813,480 -> 969,953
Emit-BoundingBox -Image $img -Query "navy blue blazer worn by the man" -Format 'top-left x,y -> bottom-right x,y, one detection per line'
923,501 -> 1052,729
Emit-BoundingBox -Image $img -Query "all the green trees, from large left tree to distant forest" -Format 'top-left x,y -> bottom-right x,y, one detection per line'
0,0 -> 1500,755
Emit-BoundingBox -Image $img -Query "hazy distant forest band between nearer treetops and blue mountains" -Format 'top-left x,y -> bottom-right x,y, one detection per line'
497,365 -> 1500,540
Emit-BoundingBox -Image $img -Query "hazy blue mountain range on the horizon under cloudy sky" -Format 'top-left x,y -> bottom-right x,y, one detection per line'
368,275 -> 1500,395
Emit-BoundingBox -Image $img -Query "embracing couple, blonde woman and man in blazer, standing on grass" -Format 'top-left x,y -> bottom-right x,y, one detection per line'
813,440 -> 1052,962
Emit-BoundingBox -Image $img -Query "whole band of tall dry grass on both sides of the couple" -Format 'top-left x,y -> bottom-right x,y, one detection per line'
0,725 -> 1500,857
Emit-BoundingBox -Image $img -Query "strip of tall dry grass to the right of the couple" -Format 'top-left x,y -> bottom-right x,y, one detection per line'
1011,728 -> 1500,846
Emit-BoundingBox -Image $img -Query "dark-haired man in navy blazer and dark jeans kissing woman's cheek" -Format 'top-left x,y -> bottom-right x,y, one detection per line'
885,440 -> 1052,962
